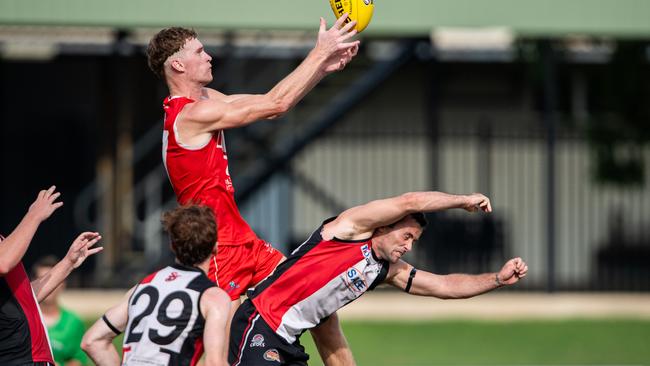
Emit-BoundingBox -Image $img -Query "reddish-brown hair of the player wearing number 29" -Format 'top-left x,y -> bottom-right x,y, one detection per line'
162,205 -> 217,266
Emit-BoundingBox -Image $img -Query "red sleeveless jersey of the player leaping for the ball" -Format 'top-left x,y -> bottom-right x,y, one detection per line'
162,97 -> 257,245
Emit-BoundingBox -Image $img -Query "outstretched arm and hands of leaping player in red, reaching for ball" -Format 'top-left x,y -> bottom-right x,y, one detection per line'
183,17 -> 359,133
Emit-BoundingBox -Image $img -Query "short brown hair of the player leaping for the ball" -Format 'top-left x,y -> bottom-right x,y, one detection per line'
147,27 -> 197,80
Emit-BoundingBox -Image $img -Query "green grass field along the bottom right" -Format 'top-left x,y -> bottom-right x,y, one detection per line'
86,320 -> 650,366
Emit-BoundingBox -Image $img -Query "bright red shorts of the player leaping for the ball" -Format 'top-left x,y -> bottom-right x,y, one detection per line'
208,239 -> 284,300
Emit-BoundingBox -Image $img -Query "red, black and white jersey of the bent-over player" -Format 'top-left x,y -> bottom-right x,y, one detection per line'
249,219 -> 389,343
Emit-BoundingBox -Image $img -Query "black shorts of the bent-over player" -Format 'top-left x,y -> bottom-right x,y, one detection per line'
228,300 -> 309,366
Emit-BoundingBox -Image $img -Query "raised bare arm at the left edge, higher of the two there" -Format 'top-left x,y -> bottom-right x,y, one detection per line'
0,186 -> 63,276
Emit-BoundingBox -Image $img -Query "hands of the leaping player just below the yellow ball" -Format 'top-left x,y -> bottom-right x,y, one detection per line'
314,13 -> 360,73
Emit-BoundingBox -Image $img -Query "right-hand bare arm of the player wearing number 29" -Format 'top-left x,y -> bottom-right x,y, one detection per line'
204,287 -> 230,366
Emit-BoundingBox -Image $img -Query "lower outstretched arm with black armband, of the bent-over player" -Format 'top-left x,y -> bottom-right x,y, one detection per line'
386,257 -> 528,299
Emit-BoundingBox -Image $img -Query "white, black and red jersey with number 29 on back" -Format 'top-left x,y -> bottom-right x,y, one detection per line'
122,264 -> 215,366
